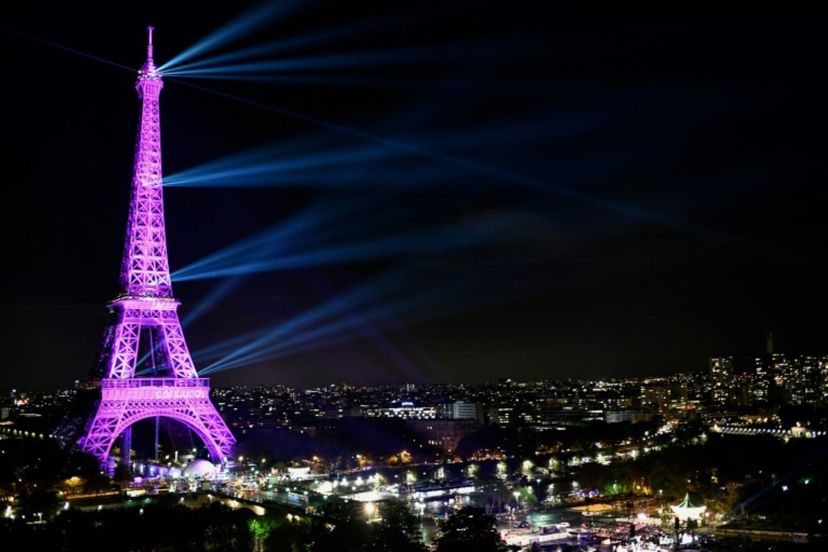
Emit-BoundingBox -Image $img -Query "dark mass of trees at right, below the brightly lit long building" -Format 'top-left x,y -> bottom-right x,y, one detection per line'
575,434 -> 828,531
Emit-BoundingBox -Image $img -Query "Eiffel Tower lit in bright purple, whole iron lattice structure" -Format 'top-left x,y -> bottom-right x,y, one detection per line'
79,27 -> 235,464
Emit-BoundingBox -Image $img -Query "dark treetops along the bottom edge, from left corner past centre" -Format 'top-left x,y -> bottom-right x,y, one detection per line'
0,500 -> 509,552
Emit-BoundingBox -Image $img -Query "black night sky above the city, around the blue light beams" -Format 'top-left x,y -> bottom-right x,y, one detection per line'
0,0 -> 828,387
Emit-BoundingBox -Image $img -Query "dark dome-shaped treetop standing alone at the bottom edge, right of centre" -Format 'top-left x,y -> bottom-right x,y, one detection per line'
436,507 -> 508,552
